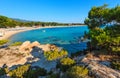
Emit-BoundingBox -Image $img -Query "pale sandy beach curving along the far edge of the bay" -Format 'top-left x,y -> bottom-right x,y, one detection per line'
0,25 -> 86,40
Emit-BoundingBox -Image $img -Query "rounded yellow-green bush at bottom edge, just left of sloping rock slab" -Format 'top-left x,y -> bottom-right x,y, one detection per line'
66,66 -> 88,78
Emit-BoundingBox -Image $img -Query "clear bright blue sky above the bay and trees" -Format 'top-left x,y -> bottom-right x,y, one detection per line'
0,0 -> 120,23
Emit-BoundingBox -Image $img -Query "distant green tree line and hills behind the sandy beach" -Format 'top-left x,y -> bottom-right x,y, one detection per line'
0,15 -> 83,28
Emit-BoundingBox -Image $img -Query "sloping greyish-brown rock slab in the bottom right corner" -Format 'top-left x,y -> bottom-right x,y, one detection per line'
82,57 -> 120,78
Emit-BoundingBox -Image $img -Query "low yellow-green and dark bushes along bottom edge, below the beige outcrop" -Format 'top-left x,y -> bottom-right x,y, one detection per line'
8,64 -> 47,78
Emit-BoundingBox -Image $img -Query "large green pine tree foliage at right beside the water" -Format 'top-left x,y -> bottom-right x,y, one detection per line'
85,5 -> 120,54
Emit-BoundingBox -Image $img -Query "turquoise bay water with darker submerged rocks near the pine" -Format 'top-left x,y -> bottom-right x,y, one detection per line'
10,26 -> 88,53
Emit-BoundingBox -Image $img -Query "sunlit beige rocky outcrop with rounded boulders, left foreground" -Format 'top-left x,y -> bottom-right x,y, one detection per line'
0,41 -> 58,67
